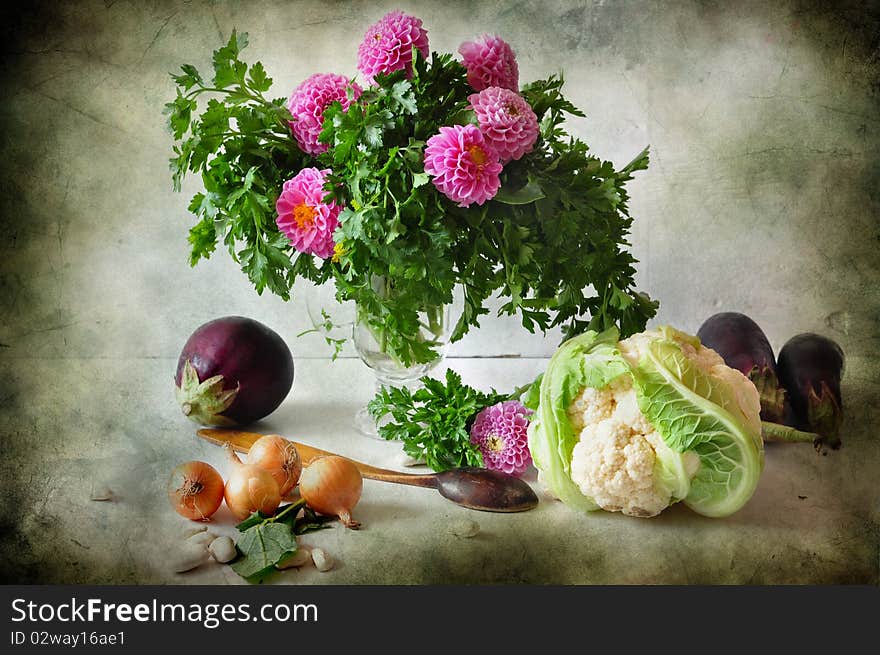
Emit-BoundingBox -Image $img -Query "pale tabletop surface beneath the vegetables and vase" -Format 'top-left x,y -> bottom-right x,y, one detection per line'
0,358 -> 880,585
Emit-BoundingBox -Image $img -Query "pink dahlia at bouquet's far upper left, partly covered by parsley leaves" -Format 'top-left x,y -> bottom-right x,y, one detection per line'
287,73 -> 363,155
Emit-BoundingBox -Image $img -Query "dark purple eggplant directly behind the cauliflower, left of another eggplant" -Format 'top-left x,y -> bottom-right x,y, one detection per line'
697,312 -> 786,423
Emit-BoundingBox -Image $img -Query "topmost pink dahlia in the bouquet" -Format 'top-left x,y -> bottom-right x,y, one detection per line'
358,11 -> 430,84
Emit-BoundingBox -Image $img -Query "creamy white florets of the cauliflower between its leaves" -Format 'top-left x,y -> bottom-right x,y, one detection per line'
569,377 -> 671,517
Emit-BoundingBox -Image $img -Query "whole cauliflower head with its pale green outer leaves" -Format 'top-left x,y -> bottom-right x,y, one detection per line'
529,327 -> 763,517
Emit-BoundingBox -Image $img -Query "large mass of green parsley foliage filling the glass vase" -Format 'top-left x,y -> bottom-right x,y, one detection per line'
166,33 -> 657,365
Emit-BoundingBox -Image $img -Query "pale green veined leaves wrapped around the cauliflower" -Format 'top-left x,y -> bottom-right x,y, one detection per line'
527,327 -> 764,517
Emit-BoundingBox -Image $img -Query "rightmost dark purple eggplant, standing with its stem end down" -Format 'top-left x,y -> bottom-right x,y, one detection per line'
778,332 -> 846,449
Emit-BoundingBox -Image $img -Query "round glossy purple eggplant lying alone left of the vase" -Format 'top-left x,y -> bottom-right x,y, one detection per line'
174,316 -> 293,426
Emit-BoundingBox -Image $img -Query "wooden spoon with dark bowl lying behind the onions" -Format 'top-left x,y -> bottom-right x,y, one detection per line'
198,428 -> 538,512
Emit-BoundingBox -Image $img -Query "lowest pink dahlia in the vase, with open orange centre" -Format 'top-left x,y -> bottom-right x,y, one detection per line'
275,168 -> 342,259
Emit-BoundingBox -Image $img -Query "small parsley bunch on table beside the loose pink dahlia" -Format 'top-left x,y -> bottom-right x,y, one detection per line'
367,369 -> 510,471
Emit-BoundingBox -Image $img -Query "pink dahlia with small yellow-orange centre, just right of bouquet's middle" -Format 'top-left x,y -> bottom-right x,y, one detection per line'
425,124 -> 501,207
